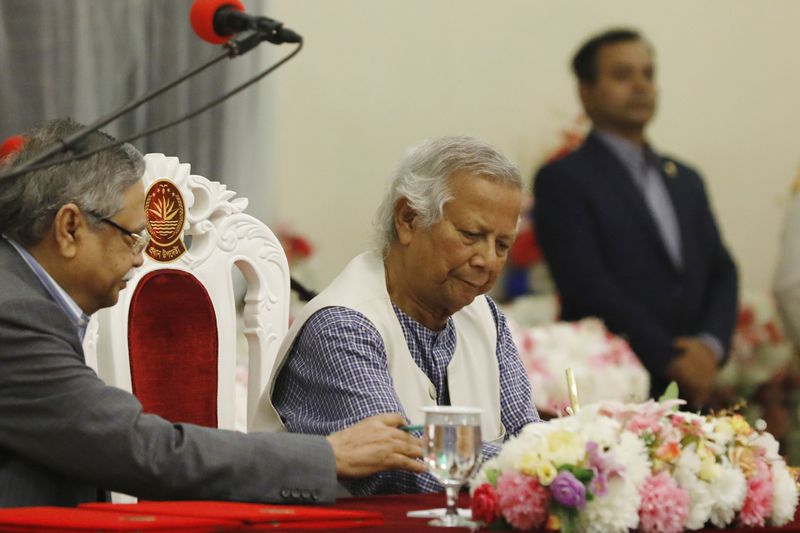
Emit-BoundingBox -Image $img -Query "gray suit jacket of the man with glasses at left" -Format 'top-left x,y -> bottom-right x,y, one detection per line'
0,238 -> 336,507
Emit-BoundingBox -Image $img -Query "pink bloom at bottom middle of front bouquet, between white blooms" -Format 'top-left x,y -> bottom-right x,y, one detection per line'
639,472 -> 689,533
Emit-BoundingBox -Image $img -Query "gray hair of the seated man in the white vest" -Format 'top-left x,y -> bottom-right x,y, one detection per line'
375,137 -> 522,253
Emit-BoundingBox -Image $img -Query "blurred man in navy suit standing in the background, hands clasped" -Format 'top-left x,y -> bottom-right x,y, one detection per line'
534,30 -> 738,406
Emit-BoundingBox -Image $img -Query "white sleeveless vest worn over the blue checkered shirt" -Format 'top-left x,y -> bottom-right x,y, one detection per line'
252,252 -> 505,443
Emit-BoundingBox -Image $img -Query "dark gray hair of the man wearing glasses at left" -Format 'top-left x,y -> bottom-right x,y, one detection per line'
0,119 -> 144,245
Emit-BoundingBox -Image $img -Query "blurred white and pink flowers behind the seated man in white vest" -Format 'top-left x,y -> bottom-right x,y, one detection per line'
509,318 -> 650,416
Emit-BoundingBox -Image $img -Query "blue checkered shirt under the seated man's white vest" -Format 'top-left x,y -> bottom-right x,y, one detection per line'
272,298 -> 539,495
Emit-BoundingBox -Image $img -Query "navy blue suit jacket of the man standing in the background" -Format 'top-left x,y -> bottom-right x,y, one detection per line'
534,134 -> 738,394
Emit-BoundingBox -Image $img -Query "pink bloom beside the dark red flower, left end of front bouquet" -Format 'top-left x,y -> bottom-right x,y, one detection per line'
497,472 -> 550,529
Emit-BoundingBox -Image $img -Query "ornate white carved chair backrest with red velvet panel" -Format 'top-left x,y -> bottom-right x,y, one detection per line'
84,154 -> 290,430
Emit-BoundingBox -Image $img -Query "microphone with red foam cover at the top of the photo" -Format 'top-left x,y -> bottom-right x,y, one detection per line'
189,0 -> 303,44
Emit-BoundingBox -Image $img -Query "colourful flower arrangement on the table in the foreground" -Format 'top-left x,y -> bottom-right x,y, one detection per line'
472,388 -> 798,533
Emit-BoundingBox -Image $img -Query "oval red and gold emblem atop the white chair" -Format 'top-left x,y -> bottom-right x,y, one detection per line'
144,179 -> 186,263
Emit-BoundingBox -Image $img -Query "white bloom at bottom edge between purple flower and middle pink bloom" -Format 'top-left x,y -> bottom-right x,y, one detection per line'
578,478 -> 642,533
